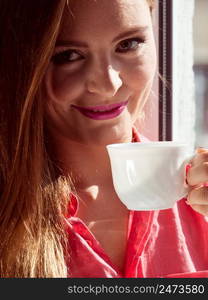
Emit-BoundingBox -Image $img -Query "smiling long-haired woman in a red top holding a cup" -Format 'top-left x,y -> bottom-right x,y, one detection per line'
0,0 -> 208,277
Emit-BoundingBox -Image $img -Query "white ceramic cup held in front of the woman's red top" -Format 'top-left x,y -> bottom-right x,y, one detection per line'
106,142 -> 193,210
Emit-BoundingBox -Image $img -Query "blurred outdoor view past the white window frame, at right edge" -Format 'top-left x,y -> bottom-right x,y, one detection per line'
193,0 -> 208,148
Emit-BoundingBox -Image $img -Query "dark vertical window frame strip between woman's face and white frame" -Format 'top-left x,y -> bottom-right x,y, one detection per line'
158,0 -> 173,141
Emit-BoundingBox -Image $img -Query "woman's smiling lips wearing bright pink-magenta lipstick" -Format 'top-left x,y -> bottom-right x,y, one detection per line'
72,100 -> 128,120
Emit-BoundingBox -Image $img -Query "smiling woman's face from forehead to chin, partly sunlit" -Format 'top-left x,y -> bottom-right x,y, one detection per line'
44,0 -> 156,145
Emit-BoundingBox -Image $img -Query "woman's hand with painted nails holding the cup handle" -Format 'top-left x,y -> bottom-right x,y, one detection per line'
186,148 -> 208,216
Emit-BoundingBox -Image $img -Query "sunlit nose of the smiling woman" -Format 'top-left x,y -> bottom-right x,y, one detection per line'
87,65 -> 122,98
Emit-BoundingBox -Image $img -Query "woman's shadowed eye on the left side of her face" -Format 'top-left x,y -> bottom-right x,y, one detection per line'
52,50 -> 83,65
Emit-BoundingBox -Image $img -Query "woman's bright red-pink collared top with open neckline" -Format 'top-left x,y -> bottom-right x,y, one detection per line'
66,130 -> 208,278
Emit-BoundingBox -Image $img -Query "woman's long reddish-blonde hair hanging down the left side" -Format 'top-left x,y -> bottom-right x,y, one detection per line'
0,0 -> 152,278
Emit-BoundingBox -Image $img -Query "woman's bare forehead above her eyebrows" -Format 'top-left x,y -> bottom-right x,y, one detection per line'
60,0 -> 151,36
